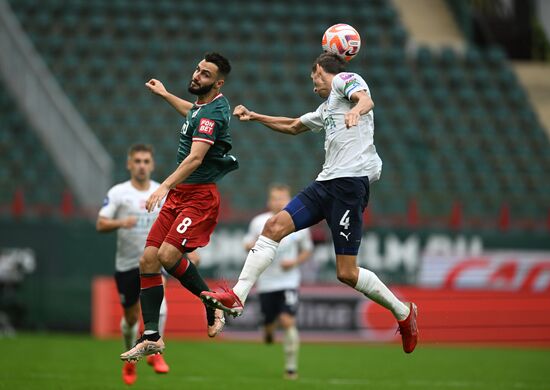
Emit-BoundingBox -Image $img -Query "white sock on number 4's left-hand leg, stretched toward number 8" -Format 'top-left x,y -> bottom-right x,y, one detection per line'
233,236 -> 279,304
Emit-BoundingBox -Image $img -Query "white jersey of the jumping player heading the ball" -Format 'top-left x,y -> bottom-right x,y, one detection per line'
300,72 -> 382,182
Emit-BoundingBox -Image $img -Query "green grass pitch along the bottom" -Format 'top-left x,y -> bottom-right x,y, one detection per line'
0,334 -> 550,390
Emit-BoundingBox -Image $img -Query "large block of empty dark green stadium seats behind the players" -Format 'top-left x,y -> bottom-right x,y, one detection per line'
0,0 -> 550,227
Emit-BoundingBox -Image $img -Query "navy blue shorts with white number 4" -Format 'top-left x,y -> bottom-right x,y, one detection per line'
285,176 -> 369,255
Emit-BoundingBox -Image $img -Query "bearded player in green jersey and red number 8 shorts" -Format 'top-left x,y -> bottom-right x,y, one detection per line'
120,53 -> 238,361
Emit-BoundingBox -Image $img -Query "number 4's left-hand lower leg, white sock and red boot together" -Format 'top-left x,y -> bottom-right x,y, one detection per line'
201,236 -> 279,317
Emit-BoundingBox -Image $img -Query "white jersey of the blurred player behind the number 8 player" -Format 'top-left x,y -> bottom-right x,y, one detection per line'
99,180 -> 160,272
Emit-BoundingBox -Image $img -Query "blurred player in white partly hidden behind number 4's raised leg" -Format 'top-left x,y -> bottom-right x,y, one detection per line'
244,184 -> 313,379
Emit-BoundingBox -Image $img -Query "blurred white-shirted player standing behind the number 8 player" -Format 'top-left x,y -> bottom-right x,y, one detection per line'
96,144 -> 170,385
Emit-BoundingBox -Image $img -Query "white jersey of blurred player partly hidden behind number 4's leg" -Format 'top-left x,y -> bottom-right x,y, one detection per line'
244,212 -> 313,293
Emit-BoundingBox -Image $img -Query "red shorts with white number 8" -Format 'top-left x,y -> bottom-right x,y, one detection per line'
149,183 -> 220,253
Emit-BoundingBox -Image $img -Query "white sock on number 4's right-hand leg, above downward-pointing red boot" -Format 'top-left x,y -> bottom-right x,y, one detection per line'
355,267 -> 410,321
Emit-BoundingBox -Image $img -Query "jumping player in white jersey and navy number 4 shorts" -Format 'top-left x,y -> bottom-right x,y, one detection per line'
201,53 -> 418,353
